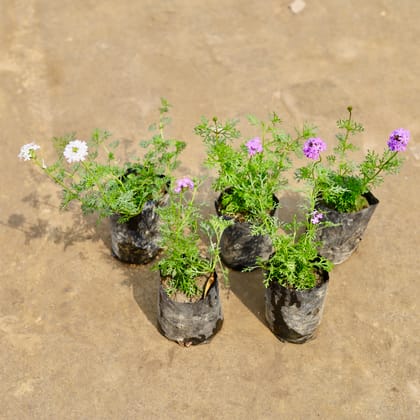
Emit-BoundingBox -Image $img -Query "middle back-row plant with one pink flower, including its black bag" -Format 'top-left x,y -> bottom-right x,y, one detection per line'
195,113 -> 313,270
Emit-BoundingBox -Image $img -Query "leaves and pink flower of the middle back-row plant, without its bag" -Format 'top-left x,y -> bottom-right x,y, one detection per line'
195,113 -> 314,222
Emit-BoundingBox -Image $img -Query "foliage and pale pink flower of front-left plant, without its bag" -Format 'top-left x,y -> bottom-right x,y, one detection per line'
154,178 -> 230,298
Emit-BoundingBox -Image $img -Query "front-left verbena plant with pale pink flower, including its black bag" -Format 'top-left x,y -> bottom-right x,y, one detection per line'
154,178 -> 230,346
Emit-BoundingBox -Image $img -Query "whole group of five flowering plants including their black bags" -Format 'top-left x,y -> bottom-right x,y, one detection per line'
19,99 -> 409,346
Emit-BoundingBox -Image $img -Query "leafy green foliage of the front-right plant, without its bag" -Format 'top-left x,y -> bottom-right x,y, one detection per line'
246,199 -> 333,290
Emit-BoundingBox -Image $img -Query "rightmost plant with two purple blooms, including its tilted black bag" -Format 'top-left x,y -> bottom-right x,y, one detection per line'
296,107 -> 410,264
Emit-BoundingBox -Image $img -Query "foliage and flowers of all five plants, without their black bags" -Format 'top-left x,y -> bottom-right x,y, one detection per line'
19,99 -> 409,298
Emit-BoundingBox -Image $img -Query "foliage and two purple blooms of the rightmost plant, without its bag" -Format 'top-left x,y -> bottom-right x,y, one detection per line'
296,107 -> 410,213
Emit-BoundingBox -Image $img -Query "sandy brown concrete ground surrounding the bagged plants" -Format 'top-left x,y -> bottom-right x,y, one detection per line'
0,0 -> 420,420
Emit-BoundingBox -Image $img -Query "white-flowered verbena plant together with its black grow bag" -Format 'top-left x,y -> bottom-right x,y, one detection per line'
18,99 -> 185,264
